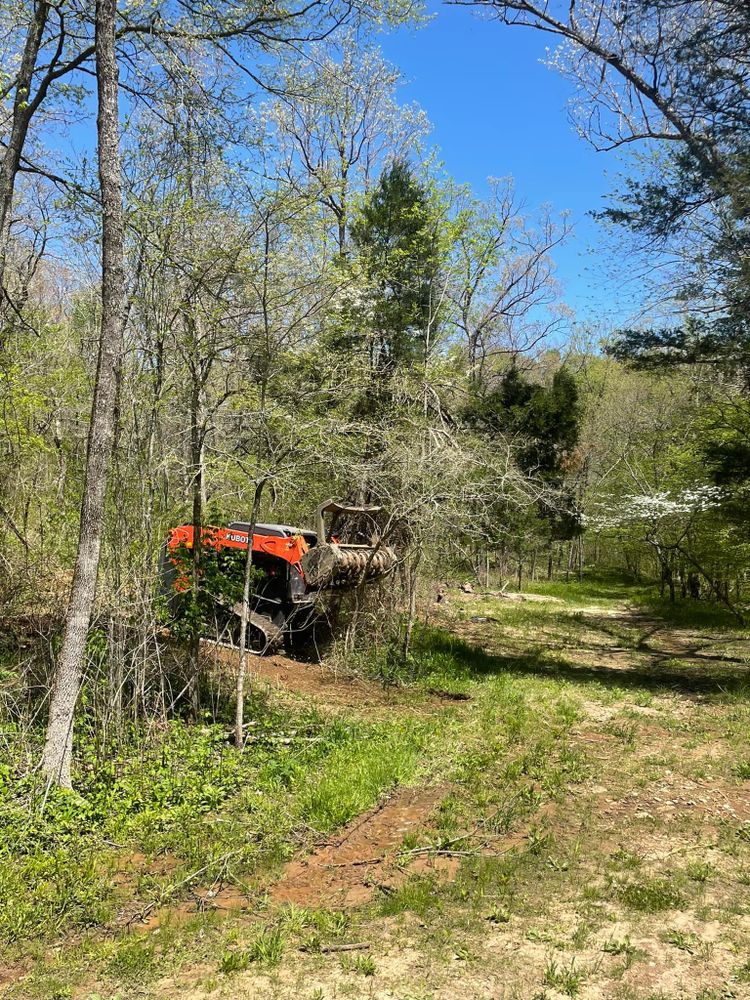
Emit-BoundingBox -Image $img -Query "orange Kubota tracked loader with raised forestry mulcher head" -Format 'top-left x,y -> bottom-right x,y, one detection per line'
162,500 -> 397,653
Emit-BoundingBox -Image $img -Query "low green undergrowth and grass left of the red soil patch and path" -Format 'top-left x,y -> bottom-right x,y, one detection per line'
0,702 -> 424,943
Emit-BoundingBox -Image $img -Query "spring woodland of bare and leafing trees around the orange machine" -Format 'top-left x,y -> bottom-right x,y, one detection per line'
0,0 -> 750,784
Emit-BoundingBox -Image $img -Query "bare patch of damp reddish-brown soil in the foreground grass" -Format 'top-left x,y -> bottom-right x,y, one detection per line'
271,785 -> 457,907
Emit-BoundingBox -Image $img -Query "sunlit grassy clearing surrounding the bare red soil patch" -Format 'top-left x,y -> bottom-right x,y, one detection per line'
9,582 -> 750,1000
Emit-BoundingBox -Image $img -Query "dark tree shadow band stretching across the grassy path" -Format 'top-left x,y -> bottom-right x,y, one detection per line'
415,628 -> 750,700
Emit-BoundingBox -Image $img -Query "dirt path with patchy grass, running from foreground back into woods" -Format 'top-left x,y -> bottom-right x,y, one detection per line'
11,594 -> 750,1000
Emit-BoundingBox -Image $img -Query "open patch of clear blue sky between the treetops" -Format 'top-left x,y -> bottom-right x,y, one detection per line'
380,4 -> 629,321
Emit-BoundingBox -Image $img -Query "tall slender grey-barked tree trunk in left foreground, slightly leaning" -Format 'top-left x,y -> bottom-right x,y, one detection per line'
42,0 -> 124,787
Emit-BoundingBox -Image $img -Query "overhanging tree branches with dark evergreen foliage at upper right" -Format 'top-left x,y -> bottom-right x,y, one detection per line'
458,0 -> 750,365
